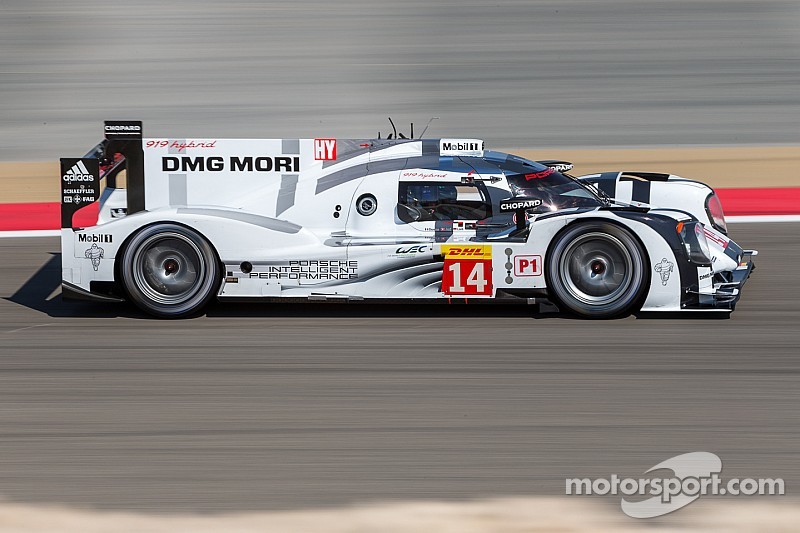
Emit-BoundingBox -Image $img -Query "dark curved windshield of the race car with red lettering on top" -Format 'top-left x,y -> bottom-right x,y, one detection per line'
465,151 -> 603,212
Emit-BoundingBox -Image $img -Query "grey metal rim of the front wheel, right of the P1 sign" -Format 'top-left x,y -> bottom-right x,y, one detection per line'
559,233 -> 634,306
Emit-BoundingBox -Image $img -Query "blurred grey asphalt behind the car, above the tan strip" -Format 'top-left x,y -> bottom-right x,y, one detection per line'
0,0 -> 800,161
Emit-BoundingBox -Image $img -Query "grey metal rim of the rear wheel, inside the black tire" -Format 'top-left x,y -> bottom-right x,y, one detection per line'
133,232 -> 206,305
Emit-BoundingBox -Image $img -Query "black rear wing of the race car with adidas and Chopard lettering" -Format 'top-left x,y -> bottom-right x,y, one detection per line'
61,121 -> 144,229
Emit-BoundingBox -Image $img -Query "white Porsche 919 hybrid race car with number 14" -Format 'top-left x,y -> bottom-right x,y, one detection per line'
61,122 -> 756,318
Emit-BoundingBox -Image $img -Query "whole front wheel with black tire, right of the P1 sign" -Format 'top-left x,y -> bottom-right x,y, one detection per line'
545,221 -> 650,318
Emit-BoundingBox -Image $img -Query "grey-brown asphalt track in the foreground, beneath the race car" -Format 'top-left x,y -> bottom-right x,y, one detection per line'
0,223 -> 800,512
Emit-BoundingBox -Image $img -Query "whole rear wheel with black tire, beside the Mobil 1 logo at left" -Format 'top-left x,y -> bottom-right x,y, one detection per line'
119,223 -> 221,318
